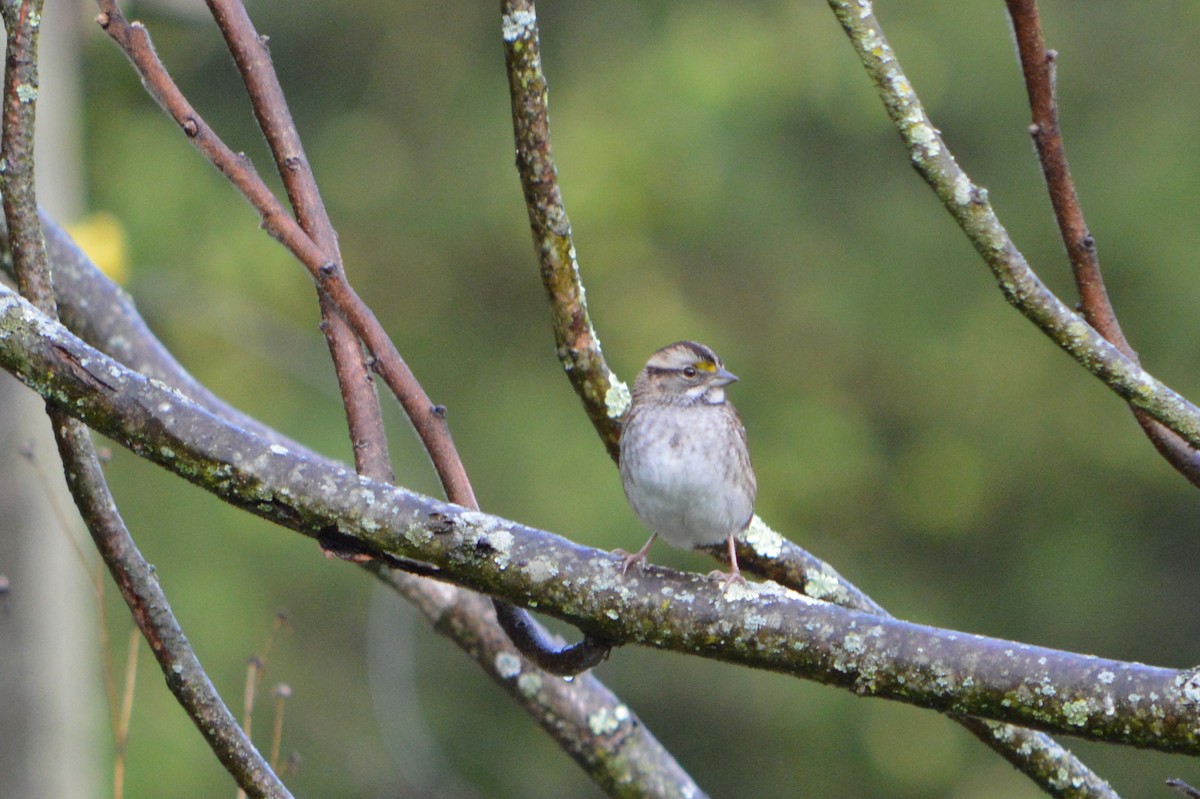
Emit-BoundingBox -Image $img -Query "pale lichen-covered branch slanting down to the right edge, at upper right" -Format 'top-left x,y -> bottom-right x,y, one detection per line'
829,0 -> 1200,446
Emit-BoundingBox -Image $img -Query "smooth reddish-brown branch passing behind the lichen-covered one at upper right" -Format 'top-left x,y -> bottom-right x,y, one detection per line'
1007,0 -> 1200,487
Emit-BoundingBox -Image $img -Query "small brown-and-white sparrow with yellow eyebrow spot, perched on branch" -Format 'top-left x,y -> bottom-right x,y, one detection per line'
620,341 -> 757,585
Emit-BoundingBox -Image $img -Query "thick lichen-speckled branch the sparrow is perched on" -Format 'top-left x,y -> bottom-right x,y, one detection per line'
0,287 -> 1200,753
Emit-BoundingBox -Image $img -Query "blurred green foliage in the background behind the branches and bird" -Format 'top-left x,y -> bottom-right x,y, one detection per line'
51,0 -> 1200,799
